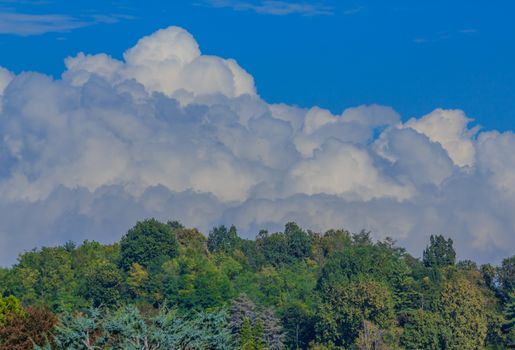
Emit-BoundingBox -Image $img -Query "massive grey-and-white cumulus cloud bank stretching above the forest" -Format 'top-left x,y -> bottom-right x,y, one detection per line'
0,27 -> 515,265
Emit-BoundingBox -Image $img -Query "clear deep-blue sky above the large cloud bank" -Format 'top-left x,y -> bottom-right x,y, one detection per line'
0,0 -> 515,131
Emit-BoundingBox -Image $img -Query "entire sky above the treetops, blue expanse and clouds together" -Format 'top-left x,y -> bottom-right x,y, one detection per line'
0,0 -> 515,265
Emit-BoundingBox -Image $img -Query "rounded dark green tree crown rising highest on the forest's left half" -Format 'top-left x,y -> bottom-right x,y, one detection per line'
120,219 -> 177,271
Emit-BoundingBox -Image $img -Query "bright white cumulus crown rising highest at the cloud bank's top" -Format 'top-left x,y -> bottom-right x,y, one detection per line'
63,27 -> 256,98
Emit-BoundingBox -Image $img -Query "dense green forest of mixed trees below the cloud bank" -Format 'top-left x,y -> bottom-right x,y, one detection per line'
0,219 -> 515,350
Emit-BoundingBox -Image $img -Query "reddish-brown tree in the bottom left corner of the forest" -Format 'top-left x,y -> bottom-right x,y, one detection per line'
0,307 -> 57,350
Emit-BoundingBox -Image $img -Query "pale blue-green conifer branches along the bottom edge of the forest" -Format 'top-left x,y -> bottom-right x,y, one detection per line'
49,305 -> 234,350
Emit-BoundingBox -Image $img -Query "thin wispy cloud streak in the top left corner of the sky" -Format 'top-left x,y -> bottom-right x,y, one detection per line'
0,12 -> 128,36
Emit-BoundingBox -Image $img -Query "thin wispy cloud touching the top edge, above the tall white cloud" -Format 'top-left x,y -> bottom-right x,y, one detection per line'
204,0 -> 334,16
